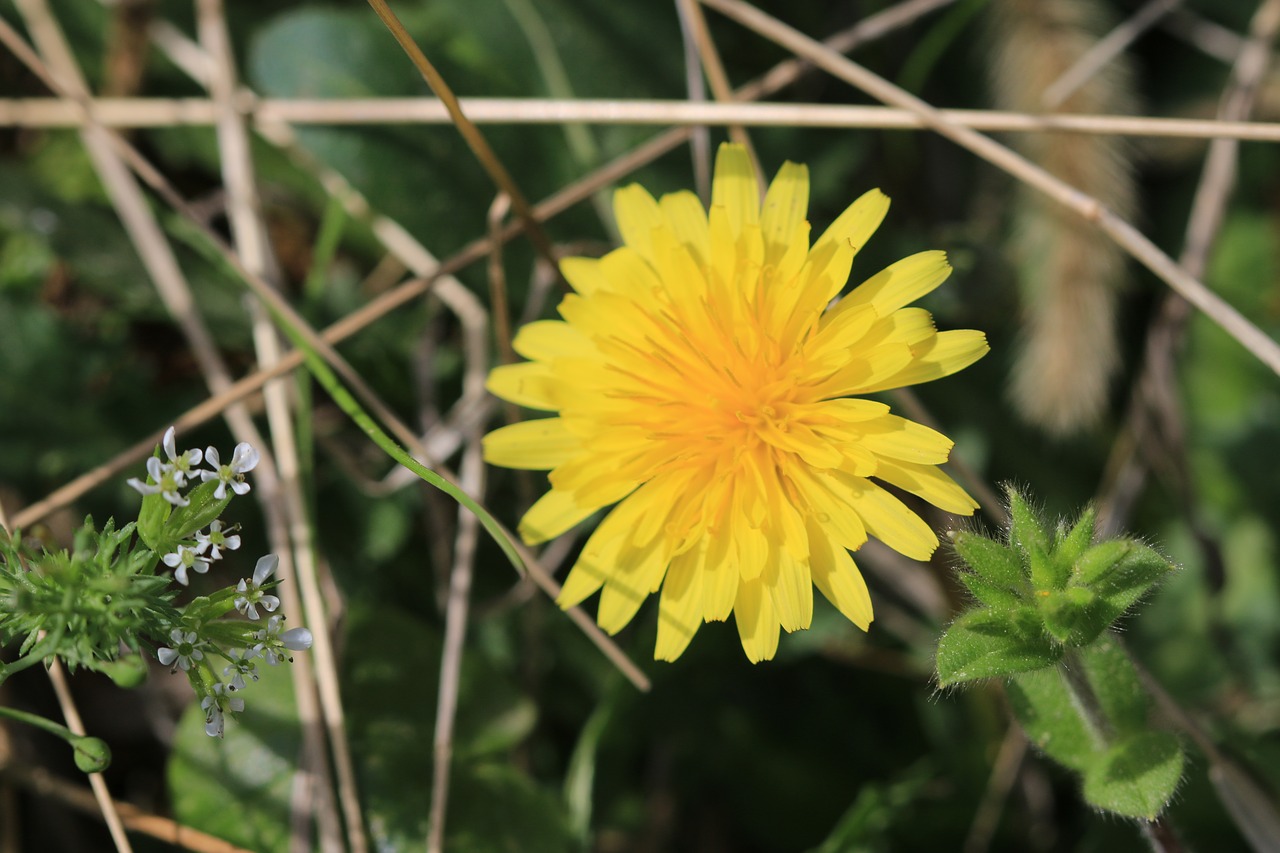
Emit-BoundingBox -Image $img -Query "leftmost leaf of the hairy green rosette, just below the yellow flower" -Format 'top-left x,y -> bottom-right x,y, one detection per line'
937,607 -> 1062,686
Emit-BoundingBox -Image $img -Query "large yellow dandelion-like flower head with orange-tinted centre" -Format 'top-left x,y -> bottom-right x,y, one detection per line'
485,145 -> 988,662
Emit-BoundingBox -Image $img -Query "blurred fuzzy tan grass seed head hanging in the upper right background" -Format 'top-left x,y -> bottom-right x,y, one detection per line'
991,0 -> 1137,435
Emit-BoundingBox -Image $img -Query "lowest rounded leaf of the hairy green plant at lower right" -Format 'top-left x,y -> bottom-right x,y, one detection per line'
1084,731 -> 1183,821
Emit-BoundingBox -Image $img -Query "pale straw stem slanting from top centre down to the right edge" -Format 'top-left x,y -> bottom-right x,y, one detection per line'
703,0 -> 1280,374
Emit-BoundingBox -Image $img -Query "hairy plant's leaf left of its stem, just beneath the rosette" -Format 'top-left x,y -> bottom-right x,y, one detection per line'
1005,666 -> 1102,772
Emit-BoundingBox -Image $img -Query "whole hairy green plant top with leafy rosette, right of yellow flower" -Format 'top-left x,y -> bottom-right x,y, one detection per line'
937,489 -> 1183,820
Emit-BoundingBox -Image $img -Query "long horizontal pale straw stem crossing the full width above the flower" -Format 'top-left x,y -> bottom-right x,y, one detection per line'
10,95 -> 1280,140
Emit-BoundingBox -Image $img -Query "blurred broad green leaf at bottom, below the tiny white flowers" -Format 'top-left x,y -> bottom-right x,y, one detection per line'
169,666 -> 302,853
